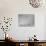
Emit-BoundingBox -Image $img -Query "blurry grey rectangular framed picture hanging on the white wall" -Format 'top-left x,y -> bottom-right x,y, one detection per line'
18,14 -> 35,27
